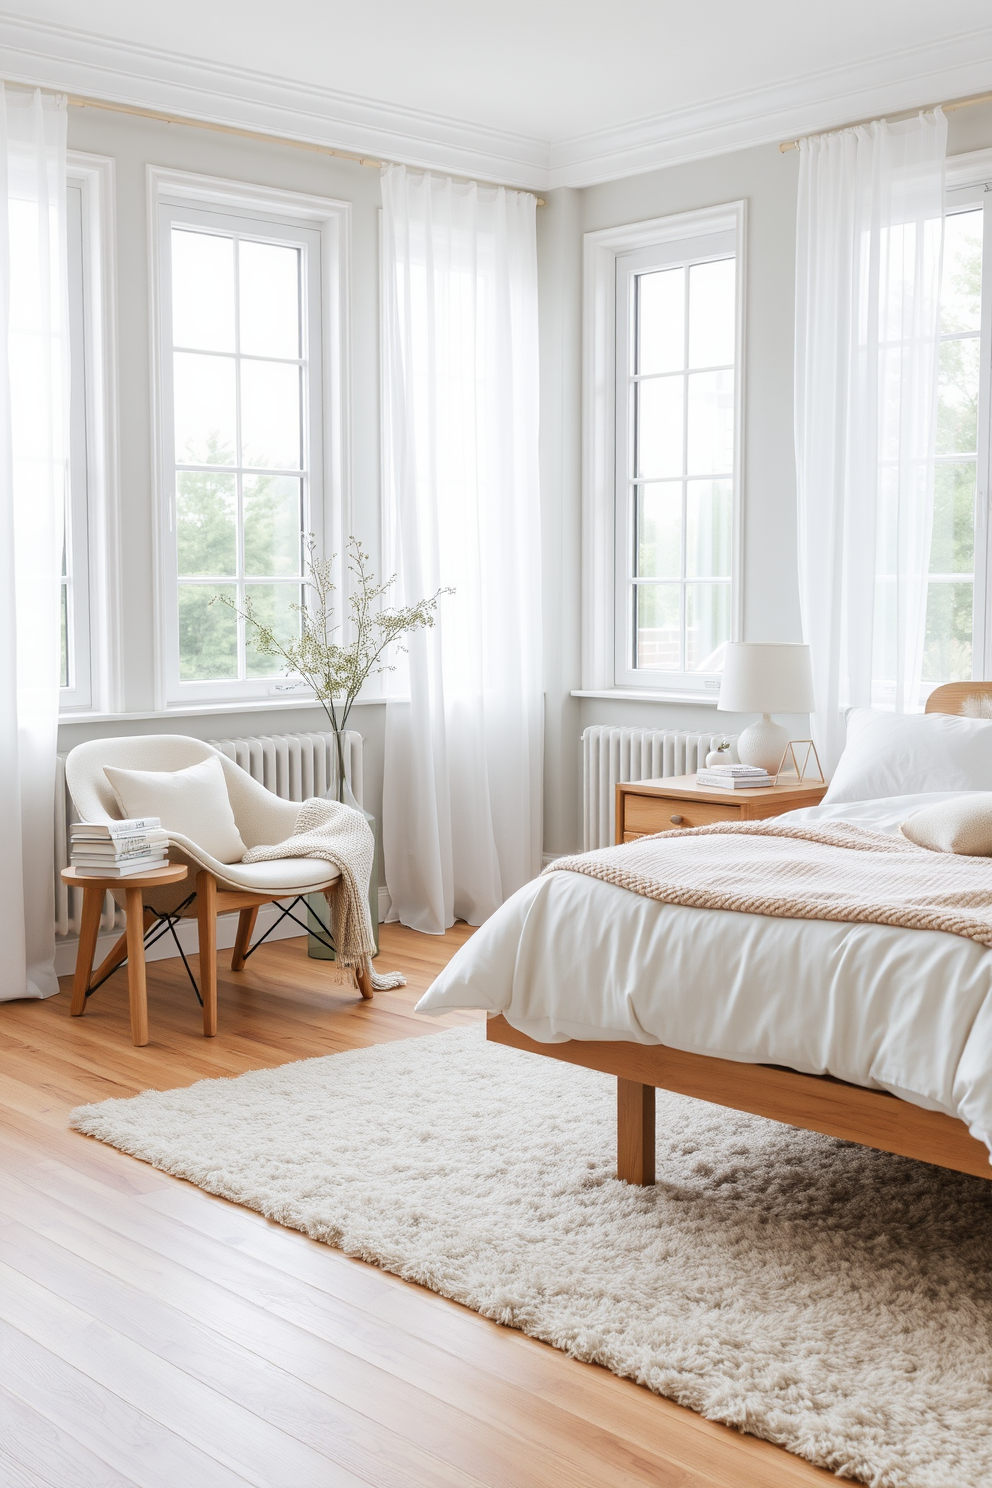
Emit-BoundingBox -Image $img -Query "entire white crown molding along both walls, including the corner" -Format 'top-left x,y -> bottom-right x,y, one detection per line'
0,12 -> 992,190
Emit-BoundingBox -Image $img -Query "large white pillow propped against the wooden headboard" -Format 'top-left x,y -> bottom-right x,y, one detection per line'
822,708 -> 992,805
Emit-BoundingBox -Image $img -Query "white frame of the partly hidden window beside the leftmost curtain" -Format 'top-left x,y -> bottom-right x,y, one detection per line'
59,150 -> 122,719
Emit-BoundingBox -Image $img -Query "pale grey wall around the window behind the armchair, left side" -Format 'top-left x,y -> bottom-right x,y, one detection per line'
59,107 -> 384,839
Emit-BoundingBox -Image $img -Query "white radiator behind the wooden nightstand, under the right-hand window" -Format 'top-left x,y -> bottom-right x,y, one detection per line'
582,723 -> 738,853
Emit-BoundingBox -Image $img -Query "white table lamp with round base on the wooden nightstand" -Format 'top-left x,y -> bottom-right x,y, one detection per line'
717,641 -> 815,775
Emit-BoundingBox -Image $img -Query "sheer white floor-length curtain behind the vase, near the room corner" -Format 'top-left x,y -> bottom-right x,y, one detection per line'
382,167 -> 543,934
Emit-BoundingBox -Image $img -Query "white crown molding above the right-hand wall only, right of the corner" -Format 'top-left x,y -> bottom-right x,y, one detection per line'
547,27 -> 992,189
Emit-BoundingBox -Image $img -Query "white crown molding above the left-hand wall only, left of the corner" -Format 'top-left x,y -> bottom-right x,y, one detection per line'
0,12 -> 547,189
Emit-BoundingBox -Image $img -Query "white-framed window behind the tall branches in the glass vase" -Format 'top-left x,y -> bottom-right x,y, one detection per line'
159,171 -> 350,704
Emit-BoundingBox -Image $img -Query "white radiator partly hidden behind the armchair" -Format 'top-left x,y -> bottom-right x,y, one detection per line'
55,729 -> 363,936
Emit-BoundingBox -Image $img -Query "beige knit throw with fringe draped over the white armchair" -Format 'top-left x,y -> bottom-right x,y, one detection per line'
241,796 -> 406,992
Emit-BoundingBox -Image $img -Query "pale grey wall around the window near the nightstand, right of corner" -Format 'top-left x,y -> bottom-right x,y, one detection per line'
537,104 -> 992,854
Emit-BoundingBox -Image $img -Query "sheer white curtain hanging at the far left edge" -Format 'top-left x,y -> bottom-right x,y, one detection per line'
0,86 -> 68,1000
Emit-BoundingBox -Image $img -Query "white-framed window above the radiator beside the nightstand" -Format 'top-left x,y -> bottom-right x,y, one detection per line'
583,202 -> 744,696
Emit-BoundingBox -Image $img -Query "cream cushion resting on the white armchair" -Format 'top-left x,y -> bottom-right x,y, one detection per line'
104,754 -> 248,863
